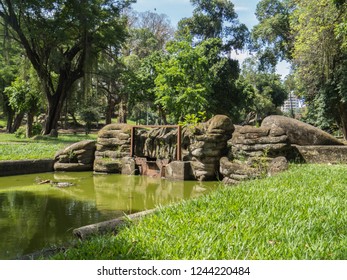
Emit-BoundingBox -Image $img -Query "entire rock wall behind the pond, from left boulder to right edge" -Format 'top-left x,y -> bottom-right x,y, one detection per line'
48,115 -> 347,184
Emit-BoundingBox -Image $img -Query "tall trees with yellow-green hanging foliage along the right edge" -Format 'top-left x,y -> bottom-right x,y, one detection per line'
252,0 -> 347,137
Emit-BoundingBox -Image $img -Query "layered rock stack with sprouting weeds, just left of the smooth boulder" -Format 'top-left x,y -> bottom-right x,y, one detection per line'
220,126 -> 291,184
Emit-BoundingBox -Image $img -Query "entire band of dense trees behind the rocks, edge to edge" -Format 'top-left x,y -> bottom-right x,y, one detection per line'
0,0 -> 347,136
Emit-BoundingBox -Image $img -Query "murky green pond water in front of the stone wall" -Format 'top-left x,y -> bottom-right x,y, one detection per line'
0,172 -> 218,259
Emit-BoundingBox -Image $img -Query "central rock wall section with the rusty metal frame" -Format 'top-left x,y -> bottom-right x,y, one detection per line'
89,115 -> 234,180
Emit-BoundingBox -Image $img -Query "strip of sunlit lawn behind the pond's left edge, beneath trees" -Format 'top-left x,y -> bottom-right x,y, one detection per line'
0,133 -> 97,160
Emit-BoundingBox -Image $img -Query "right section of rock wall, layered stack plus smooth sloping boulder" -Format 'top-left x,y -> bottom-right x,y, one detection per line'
220,116 -> 347,184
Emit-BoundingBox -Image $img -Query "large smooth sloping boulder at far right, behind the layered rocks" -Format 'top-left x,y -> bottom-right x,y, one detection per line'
261,115 -> 343,146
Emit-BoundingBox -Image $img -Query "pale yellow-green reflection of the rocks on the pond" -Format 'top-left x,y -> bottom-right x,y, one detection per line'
94,176 -> 208,213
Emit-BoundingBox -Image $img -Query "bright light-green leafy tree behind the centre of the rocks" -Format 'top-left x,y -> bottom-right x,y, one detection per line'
154,38 -> 212,123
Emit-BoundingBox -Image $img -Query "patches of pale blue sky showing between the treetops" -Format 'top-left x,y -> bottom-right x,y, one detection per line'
132,0 -> 289,77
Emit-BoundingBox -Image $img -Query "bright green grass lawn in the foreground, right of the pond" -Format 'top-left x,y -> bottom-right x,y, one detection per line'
51,165 -> 347,260
